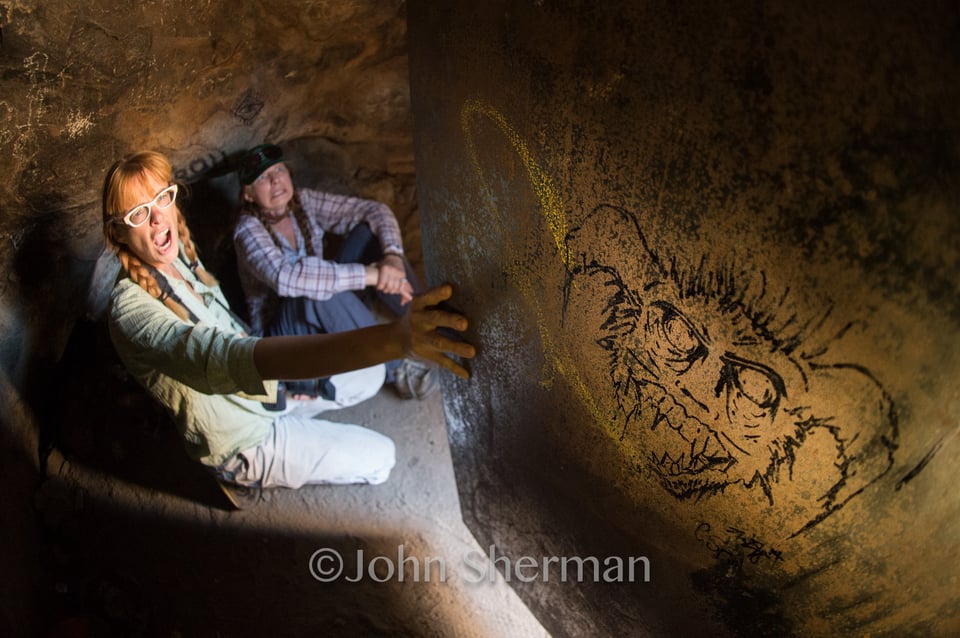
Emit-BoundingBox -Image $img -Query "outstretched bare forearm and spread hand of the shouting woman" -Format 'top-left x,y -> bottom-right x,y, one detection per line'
253,284 -> 476,379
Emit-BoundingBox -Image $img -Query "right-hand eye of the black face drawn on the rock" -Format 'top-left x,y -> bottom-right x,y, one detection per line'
716,354 -> 787,428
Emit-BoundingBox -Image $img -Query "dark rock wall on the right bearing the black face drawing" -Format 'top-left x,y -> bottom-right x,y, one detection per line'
408,0 -> 960,636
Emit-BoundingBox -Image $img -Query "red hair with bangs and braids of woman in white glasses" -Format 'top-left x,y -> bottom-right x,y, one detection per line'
103,151 -> 217,321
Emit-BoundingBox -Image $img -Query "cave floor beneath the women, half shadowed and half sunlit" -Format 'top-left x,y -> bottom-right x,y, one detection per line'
37,356 -> 547,638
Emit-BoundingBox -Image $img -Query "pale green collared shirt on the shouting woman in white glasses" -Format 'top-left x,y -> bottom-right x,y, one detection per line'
109,252 -> 275,467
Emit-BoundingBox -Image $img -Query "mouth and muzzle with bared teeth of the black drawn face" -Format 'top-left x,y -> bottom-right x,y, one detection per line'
646,385 -> 736,481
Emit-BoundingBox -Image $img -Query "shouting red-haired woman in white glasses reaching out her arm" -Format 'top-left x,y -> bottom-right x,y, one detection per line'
103,151 -> 473,506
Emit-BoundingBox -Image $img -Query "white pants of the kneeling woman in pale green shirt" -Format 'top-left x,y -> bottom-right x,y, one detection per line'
221,365 -> 396,488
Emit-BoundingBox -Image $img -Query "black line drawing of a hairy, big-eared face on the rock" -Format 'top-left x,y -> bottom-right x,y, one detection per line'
563,205 -> 897,536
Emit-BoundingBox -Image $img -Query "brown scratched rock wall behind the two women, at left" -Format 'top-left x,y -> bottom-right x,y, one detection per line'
0,0 -> 422,636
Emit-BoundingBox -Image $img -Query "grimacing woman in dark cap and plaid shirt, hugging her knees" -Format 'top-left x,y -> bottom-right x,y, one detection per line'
234,144 -> 438,398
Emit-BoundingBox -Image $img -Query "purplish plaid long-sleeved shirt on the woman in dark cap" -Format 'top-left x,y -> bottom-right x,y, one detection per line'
233,188 -> 403,334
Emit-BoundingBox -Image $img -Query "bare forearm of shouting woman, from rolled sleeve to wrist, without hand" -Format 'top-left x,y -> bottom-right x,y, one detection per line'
253,324 -> 407,379
